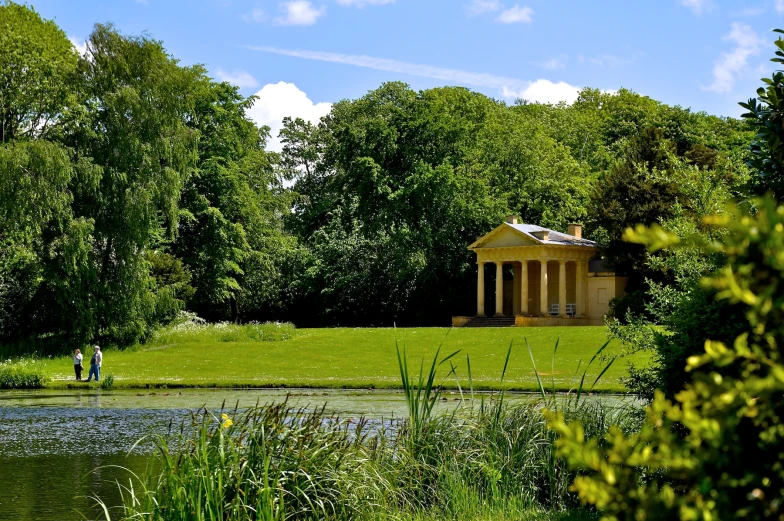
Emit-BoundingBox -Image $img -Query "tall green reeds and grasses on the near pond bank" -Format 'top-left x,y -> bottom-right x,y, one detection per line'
99,345 -> 638,521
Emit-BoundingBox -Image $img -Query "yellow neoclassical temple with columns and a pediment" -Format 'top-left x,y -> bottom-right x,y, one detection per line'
452,216 -> 626,326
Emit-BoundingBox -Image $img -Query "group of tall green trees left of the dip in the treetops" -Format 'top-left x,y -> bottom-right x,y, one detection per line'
0,2 -> 296,353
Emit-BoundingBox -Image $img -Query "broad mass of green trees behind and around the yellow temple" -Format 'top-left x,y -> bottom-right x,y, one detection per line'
281,83 -> 750,325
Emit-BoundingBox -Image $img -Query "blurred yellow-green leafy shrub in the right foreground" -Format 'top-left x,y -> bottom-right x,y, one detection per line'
553,198 -> 784,520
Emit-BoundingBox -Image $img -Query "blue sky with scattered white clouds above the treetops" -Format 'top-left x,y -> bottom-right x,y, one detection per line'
30,0 -> 784,148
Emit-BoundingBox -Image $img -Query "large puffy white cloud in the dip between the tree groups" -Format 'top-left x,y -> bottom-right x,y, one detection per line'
248,81 -> 332,152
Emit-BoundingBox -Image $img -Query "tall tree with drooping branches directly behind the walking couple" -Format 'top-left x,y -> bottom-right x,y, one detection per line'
65,25 -> 204,345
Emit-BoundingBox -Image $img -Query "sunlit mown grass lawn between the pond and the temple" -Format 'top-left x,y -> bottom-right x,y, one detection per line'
38,327 -> 646,391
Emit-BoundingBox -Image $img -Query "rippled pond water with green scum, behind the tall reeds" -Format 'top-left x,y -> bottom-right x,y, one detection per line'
0,389 -> 627,521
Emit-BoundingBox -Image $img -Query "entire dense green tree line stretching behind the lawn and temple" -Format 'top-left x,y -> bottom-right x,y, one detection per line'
0,2 -> 753,350
